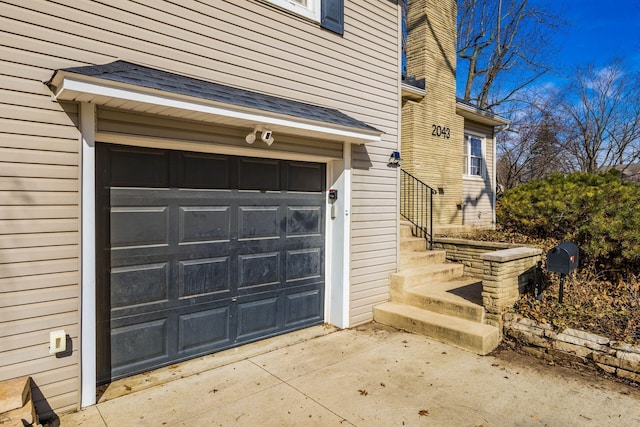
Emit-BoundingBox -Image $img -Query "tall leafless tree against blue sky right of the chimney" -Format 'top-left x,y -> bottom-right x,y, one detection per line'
457,0 -> 559,110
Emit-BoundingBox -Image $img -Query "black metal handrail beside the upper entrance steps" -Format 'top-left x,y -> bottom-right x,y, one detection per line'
400,169 -> 438,250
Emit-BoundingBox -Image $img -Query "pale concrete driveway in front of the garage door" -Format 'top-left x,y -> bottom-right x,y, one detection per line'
60,324 -> 640,427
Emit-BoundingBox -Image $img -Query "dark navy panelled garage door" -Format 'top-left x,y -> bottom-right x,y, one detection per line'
96,144 -> 325,383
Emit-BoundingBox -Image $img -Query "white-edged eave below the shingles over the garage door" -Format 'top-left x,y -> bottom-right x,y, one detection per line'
47,64 -> 383,144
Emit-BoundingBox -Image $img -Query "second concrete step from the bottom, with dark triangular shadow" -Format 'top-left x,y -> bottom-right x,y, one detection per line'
391,277 -> 485,323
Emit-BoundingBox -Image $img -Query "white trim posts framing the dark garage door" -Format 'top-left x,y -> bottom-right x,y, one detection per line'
79,102 -> 351,407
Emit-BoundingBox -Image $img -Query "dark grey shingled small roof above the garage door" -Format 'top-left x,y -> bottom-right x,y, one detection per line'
60,61 -> 378,131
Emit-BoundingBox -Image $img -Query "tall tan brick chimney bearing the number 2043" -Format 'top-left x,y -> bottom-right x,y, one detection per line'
402,0 -> 464,224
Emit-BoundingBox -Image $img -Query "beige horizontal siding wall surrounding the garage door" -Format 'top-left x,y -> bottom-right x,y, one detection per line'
0,0 -> 399,412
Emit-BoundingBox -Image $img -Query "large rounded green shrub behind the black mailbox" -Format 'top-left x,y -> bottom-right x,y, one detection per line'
497,172 -> 640,271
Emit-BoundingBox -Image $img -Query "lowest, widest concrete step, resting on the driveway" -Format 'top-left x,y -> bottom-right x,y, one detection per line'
373,302 -> 500,355
